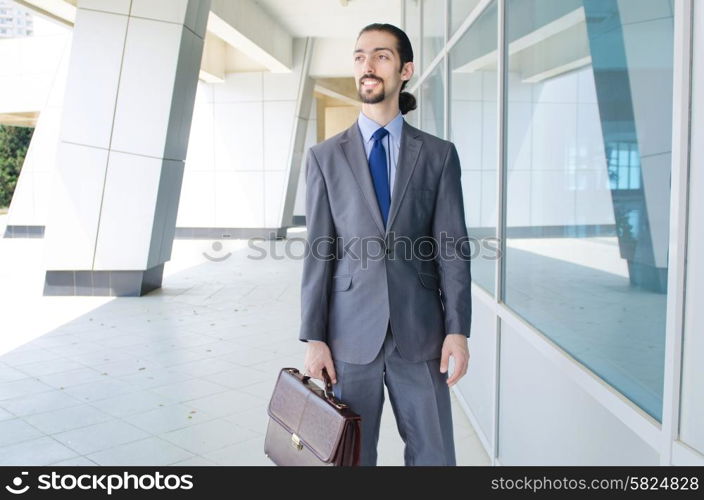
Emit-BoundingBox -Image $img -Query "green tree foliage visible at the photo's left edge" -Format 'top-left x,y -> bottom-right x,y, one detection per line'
0,125 -> 34,207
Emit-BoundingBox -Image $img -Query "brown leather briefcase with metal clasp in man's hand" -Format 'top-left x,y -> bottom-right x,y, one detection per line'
264,368 -> 362,466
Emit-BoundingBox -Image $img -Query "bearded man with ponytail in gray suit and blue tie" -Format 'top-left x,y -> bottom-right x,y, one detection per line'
299,24 -> 472,465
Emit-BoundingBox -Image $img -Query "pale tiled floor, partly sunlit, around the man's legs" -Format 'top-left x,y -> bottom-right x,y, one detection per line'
0,216 -> 489,465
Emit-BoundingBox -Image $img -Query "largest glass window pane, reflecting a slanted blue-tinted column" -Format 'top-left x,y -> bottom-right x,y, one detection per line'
505,0 -> 673,420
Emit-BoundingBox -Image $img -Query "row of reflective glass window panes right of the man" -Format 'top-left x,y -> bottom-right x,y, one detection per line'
405,0 -> 673,420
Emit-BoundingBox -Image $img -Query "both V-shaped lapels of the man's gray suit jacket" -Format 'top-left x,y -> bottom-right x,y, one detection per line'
339,120 -> 423,235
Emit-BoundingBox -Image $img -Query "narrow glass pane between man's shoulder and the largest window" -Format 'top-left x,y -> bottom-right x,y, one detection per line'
449,2 -> 498,295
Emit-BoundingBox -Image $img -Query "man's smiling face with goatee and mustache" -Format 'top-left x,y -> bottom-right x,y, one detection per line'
353,31 -> 413,104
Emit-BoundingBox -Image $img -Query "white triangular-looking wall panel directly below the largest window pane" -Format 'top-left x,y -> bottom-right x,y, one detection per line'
499,323 -> 659,465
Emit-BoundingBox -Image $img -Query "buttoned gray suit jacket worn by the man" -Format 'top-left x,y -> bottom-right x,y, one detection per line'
299,121 -> 472,364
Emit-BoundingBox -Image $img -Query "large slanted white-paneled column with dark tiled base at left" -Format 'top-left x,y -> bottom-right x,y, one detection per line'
44,0 -> 210,296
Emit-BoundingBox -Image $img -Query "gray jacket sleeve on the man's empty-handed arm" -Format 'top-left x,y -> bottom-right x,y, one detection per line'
433,143 -> 472,337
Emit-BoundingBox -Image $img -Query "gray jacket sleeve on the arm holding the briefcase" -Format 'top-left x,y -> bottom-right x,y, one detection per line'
299,149 -> 336,342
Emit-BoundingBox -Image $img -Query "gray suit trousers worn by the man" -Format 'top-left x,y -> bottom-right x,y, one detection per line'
333,324 -> 456,465
